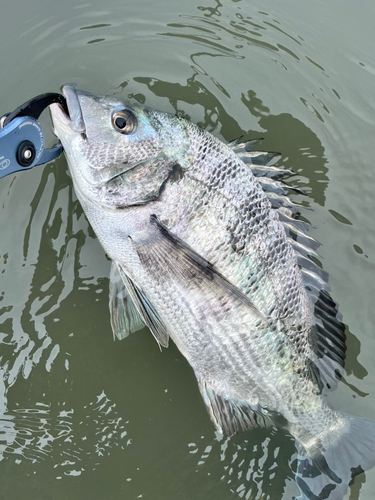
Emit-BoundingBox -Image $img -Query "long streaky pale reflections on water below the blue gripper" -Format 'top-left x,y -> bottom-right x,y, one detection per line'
1,168 -> 80,387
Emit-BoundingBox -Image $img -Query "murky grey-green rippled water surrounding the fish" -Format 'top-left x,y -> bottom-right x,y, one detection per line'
0,0 -> 375,500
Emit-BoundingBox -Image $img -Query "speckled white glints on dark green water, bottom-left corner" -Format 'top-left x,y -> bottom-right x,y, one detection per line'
0,392 -> 129,468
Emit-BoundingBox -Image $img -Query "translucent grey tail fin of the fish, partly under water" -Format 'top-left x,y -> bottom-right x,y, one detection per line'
292,413 -> 375,500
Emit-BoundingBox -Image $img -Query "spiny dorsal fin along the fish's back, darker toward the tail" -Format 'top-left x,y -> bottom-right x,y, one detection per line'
234,140 -> 346,389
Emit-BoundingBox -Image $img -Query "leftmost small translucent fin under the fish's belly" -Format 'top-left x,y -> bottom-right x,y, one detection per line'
109,262 -> 145,340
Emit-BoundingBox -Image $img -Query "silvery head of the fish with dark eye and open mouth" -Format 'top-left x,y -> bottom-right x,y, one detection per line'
50,86 -> 190,208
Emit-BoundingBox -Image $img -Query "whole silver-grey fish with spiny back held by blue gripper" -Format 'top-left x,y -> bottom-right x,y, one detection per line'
50,86 -> 375,500
